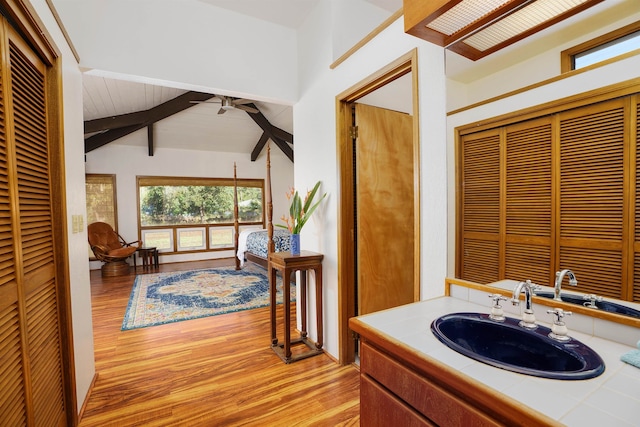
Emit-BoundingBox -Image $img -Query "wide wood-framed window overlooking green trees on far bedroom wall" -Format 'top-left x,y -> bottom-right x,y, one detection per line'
138,177 -> 264,253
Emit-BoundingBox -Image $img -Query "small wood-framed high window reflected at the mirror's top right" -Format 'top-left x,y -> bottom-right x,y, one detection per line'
561,22 -> 640,73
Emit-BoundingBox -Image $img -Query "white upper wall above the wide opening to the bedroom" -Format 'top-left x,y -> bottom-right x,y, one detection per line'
55,0 -> 298,105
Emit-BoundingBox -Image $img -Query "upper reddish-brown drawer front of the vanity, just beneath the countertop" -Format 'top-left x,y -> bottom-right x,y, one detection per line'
360,342 -> 503,426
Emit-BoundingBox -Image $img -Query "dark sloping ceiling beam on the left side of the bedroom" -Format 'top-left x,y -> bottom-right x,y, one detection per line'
84,92 -> 215,154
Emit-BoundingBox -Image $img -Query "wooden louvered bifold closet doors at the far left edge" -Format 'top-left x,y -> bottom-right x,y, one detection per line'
0,21 -> 67,426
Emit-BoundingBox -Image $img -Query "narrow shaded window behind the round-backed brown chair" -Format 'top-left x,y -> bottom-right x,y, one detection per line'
85,174 -> 118,259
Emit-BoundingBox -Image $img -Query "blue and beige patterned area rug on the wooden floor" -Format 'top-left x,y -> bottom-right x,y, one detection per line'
122,263 -> 296,331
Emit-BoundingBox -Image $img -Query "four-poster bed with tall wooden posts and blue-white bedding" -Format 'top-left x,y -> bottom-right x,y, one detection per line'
233,145 -> 290,270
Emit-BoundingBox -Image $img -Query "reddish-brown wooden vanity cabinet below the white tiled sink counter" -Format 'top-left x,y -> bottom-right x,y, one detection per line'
349,318 -> 560,427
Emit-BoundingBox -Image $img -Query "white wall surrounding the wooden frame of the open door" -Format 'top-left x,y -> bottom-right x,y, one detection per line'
293,5 -> 447,358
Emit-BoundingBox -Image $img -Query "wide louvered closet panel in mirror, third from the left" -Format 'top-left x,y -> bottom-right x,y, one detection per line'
558,98 -> 631,298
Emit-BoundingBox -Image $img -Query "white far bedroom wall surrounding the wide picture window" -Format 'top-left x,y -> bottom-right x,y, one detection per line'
85,135 -> 293,269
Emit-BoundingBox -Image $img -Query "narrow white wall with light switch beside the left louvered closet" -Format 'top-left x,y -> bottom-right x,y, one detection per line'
31,0 -> 95,411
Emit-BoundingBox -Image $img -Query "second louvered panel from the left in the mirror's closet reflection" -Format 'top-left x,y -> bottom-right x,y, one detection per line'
504,117 -> 553,285
